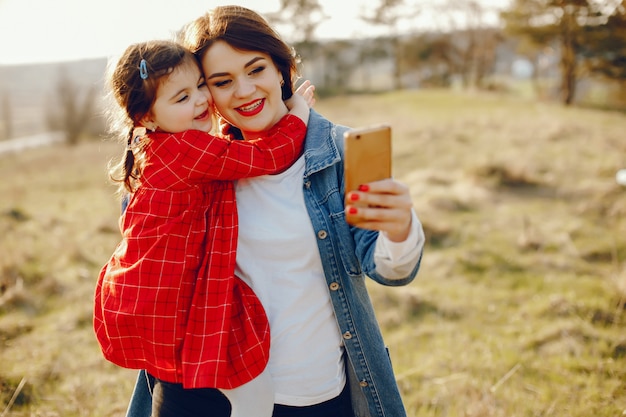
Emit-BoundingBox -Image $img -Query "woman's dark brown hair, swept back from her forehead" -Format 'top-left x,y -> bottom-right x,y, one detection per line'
180,6 -> 298,100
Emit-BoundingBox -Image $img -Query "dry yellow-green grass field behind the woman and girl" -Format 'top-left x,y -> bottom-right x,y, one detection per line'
0,91 -> 626,417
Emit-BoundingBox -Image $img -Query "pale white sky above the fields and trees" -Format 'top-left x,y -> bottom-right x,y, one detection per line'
0,0 -> 505,65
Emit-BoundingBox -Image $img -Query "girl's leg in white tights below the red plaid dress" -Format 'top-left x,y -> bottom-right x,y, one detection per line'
220,368 -> 274,417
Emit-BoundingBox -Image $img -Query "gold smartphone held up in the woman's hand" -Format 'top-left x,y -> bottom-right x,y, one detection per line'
344,124 -> 391,192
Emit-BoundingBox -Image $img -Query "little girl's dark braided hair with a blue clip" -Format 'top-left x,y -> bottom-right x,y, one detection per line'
108,40 -> 199,192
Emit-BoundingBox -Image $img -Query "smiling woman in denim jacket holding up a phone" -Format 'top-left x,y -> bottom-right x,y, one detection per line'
128,6 -> 424,417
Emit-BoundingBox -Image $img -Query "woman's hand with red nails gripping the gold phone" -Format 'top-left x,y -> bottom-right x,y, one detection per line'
345,179 -> 413,242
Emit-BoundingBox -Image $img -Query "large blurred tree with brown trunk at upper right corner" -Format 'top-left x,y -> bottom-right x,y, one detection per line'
501,0 -> 623,105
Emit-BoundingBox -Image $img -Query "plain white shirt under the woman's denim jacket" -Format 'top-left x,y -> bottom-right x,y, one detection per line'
235,157 -> 423,406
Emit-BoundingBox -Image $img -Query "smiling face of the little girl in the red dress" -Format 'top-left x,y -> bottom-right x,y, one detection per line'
142,63 -> 213,133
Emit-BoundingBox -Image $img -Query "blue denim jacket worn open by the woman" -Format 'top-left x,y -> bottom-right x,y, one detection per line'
127,110 -> 421,417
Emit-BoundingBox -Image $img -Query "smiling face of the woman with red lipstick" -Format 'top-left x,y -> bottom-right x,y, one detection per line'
202,41 -> 288,139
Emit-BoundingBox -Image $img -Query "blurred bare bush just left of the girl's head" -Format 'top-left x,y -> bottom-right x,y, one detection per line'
47,66 -> 96,145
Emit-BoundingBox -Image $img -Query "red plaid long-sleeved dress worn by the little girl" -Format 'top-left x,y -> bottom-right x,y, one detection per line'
94,115 -> 306,388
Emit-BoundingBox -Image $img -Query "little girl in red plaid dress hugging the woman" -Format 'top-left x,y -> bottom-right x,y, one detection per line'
94,41 -> 313,417
